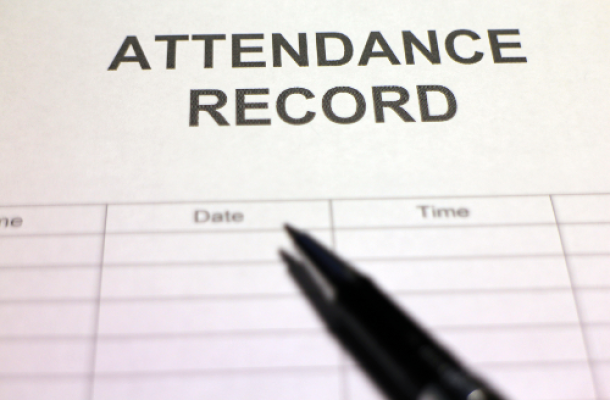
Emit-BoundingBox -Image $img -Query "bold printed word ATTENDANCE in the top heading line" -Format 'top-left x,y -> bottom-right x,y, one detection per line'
108,29 -> 527,71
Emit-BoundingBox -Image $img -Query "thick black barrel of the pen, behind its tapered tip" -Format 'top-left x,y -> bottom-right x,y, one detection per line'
331,277 -> 501,400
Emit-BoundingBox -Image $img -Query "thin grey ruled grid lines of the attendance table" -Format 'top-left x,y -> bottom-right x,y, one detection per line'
0,196 -> 610,400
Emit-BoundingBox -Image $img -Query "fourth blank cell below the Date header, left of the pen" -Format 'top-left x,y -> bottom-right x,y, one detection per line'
96,332 -> 339,374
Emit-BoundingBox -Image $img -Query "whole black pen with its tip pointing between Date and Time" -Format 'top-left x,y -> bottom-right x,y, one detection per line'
280,225 -> 502,400
